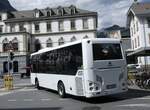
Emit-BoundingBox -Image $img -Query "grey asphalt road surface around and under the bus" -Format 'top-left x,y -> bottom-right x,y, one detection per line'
0,75 -> 150,110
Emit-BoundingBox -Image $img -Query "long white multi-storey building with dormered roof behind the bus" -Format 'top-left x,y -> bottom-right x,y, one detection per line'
0,5 -> 97,73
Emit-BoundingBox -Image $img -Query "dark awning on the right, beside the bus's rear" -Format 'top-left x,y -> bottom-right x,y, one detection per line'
127,47 -> 150,57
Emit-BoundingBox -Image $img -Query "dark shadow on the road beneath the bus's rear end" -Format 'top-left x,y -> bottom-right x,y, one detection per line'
69,89 -> 150,104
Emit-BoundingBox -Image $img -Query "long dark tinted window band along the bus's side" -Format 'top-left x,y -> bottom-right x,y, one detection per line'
32,44 -> 82,75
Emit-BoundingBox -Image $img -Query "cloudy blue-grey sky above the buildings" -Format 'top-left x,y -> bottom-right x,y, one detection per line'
9,0 -> 150,29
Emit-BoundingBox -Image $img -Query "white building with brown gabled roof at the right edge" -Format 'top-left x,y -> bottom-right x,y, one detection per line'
127,2 -> 150,65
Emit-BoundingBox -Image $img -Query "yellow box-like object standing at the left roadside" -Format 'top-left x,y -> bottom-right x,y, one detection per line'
4,75 -> 13,90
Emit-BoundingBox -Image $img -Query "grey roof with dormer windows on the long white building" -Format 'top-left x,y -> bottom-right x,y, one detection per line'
5,5 -> 97,22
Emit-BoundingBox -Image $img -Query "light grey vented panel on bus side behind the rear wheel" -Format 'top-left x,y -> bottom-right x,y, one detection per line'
75,77 -> 83,96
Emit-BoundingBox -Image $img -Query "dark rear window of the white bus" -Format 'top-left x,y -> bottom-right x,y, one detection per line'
93,43 -> 122,60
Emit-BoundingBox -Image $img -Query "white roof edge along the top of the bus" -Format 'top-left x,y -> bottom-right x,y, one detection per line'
31,38 -> 120,56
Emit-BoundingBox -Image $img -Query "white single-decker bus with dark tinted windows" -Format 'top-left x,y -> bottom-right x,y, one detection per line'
31,38 -> 127,98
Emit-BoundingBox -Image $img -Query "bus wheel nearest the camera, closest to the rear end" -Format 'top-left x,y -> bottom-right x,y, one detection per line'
58,82 -> 66,98
